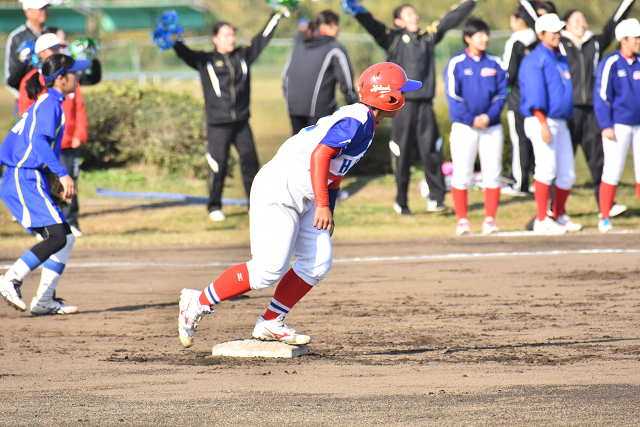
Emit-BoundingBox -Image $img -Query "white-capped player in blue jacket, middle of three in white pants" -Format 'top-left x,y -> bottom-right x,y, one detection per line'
519,14 -> 582,234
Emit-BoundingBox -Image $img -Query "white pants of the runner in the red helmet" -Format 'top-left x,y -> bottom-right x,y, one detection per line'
247,162 -> 333,290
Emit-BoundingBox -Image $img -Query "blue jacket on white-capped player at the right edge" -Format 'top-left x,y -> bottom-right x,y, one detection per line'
593,52 -> 640,129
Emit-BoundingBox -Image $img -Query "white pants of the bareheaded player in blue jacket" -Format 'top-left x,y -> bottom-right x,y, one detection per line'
450,123 -> 504,190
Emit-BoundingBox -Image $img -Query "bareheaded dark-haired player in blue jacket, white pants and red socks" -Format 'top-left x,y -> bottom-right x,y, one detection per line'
444,18 -> 507,235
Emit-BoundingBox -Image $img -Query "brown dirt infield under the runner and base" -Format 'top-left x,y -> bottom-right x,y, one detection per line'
0,235 -> 640,426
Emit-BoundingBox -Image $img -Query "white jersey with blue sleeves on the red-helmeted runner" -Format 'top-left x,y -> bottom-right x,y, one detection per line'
270,103 -> 376,199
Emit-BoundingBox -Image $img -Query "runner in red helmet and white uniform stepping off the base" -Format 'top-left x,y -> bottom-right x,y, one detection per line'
178,62 -> 422,347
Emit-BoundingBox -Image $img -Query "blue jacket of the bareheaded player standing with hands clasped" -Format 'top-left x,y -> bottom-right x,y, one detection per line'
444,50 -> 507,126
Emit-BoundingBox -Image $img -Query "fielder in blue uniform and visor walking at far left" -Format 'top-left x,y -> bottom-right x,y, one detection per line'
0,54 -> 90,315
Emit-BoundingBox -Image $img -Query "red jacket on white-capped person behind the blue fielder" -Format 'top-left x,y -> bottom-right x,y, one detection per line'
18,69 -> 88,149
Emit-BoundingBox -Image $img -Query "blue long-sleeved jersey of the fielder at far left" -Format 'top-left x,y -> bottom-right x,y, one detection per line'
0,88 -> 68,177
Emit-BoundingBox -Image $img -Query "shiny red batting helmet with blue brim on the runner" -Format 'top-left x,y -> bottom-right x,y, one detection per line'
358,62 -> 422,111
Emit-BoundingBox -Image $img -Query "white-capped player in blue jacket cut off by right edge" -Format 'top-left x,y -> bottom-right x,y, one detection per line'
593,19 -> 640,233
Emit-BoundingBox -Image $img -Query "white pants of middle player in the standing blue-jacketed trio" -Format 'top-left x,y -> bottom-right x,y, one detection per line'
524,117 -> 576,190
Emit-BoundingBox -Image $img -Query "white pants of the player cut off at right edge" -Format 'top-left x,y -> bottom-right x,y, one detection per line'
602,123 -> 640,185
